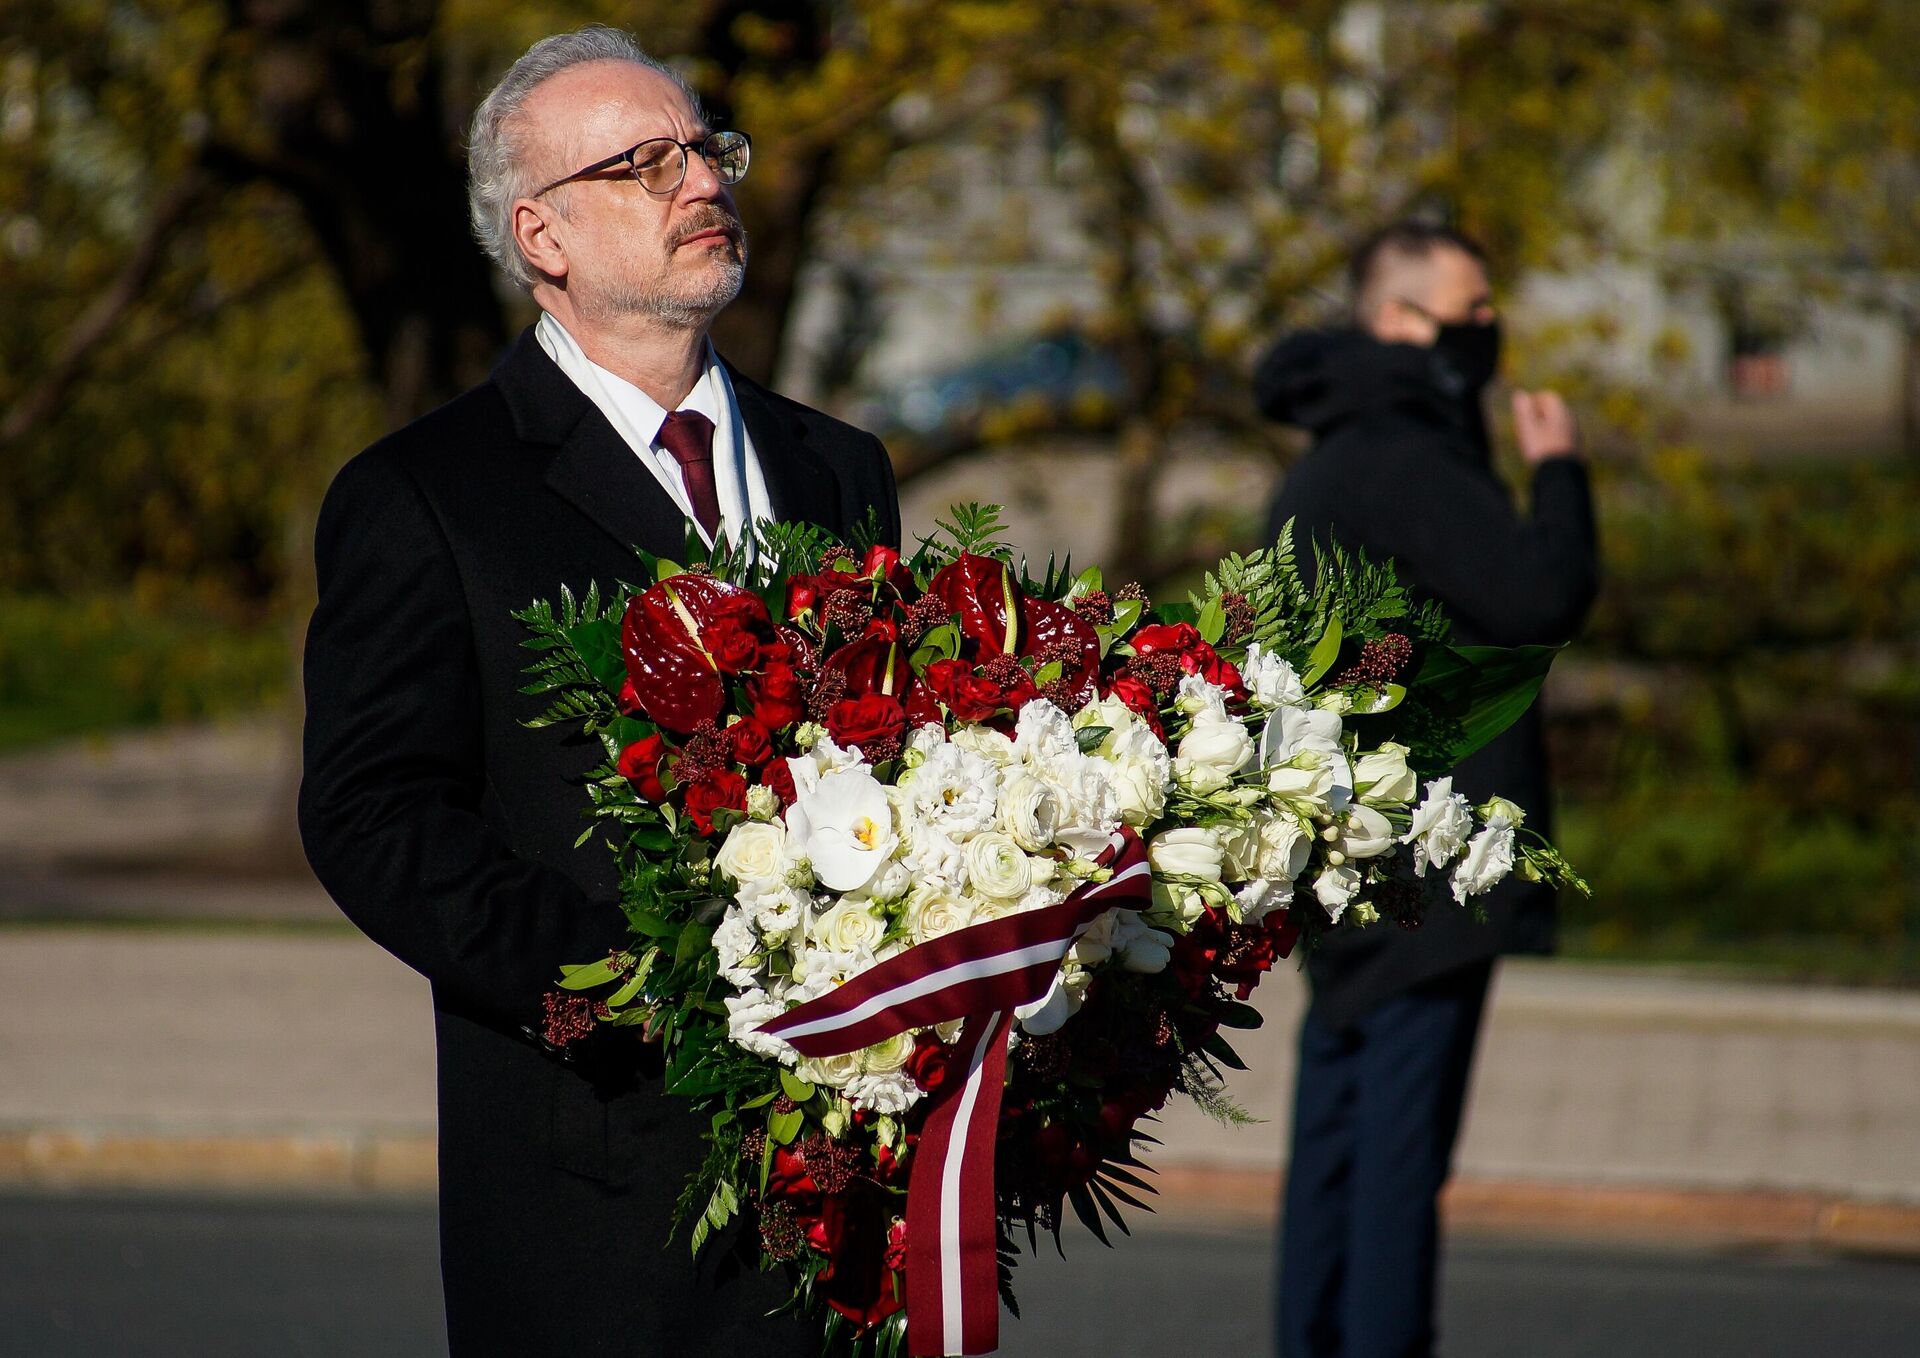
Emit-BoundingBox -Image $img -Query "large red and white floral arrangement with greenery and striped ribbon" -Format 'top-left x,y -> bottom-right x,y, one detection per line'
516,505 -> 1576,1352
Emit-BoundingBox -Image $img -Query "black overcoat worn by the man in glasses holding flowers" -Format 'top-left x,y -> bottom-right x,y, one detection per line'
300,330 -> 900,1358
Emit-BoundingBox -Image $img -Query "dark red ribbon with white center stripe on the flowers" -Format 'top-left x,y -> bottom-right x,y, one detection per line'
760,828 -> 1152,1356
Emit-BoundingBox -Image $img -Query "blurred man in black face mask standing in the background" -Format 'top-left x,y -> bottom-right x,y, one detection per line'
1254,223 -> 1597,1358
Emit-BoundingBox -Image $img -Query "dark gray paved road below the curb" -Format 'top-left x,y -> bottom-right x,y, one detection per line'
0,1195 -> 1920,1358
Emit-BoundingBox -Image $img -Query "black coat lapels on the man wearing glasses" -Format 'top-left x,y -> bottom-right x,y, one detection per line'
493,327 -> 843,555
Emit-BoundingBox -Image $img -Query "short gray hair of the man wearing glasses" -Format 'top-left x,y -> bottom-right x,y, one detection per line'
467,23 -> 701,288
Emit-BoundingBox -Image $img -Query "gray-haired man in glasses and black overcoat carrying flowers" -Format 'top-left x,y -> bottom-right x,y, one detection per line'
300,27 -> 900,1358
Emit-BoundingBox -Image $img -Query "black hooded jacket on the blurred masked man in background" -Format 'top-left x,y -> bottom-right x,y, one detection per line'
1254,330 -> 1597,1024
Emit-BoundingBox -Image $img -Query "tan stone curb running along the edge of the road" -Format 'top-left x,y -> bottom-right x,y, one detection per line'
11,1128 -> 1920,1258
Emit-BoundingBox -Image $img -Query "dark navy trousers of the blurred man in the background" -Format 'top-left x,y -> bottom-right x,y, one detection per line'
1279,962 -> 1492,1358
